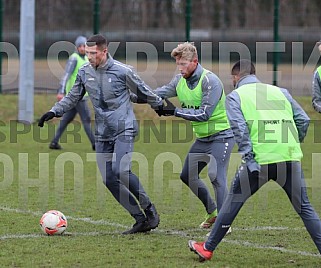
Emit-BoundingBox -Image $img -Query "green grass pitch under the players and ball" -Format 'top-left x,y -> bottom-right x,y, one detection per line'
0,95 -> 321,267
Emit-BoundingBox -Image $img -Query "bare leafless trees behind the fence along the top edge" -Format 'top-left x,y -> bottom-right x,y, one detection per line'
3,0 -> 321,31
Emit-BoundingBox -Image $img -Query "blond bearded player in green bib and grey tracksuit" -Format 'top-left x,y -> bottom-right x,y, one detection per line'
155,42 -> 234,228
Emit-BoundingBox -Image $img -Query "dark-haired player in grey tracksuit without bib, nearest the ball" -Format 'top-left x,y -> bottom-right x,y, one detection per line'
38,34 -> 163,234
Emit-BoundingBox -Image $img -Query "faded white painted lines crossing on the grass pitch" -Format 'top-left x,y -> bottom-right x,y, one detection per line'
0,206 -> 321,258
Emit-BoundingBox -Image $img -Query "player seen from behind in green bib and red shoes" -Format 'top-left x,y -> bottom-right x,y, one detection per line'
188,60 -> 321,261
